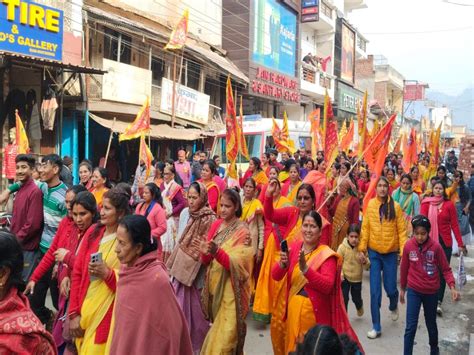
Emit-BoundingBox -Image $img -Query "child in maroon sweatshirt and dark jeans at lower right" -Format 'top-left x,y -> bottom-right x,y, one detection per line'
400,215 -> 459,355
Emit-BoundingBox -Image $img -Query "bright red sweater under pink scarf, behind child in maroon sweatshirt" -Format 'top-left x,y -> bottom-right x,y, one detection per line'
420,201 -> 464,248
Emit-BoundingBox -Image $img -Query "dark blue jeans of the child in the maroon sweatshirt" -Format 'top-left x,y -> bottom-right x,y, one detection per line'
403,288 -> 439,355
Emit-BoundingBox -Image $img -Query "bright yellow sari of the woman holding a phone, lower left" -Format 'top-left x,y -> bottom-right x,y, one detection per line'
76,233 -> 120,355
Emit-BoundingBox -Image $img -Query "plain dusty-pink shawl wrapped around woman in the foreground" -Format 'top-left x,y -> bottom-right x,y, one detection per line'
109,252 -> 193,355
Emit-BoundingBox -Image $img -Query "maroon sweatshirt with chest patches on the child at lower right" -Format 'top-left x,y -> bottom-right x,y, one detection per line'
400,238 -> 455,295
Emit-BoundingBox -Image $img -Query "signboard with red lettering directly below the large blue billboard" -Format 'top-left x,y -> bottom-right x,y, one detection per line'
250,67 -> 301,103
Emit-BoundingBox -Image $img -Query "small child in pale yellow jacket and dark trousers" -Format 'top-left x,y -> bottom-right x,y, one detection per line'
337,224 -> 370,317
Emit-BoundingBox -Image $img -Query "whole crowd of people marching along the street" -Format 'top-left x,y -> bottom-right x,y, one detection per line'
0,145 -> 474,355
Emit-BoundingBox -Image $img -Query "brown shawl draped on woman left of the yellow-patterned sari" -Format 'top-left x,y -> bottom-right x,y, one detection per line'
166,182 -> 216,286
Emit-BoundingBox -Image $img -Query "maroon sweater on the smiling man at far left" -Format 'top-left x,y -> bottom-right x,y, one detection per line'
10,179 -> 43,251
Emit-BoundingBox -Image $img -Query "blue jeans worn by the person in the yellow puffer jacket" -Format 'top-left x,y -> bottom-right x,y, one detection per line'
369,249 -> 398,332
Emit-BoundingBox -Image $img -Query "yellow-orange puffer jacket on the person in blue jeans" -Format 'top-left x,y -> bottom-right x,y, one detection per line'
358,197 -> 407,255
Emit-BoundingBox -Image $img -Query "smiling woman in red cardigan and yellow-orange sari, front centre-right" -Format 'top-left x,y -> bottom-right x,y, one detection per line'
272,211 -> 362,354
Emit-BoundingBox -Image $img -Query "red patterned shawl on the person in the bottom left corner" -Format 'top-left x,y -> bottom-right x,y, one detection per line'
0,287 -> 57,355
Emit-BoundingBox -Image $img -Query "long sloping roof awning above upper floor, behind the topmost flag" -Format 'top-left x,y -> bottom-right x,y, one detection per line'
83,2 -> 249,84
